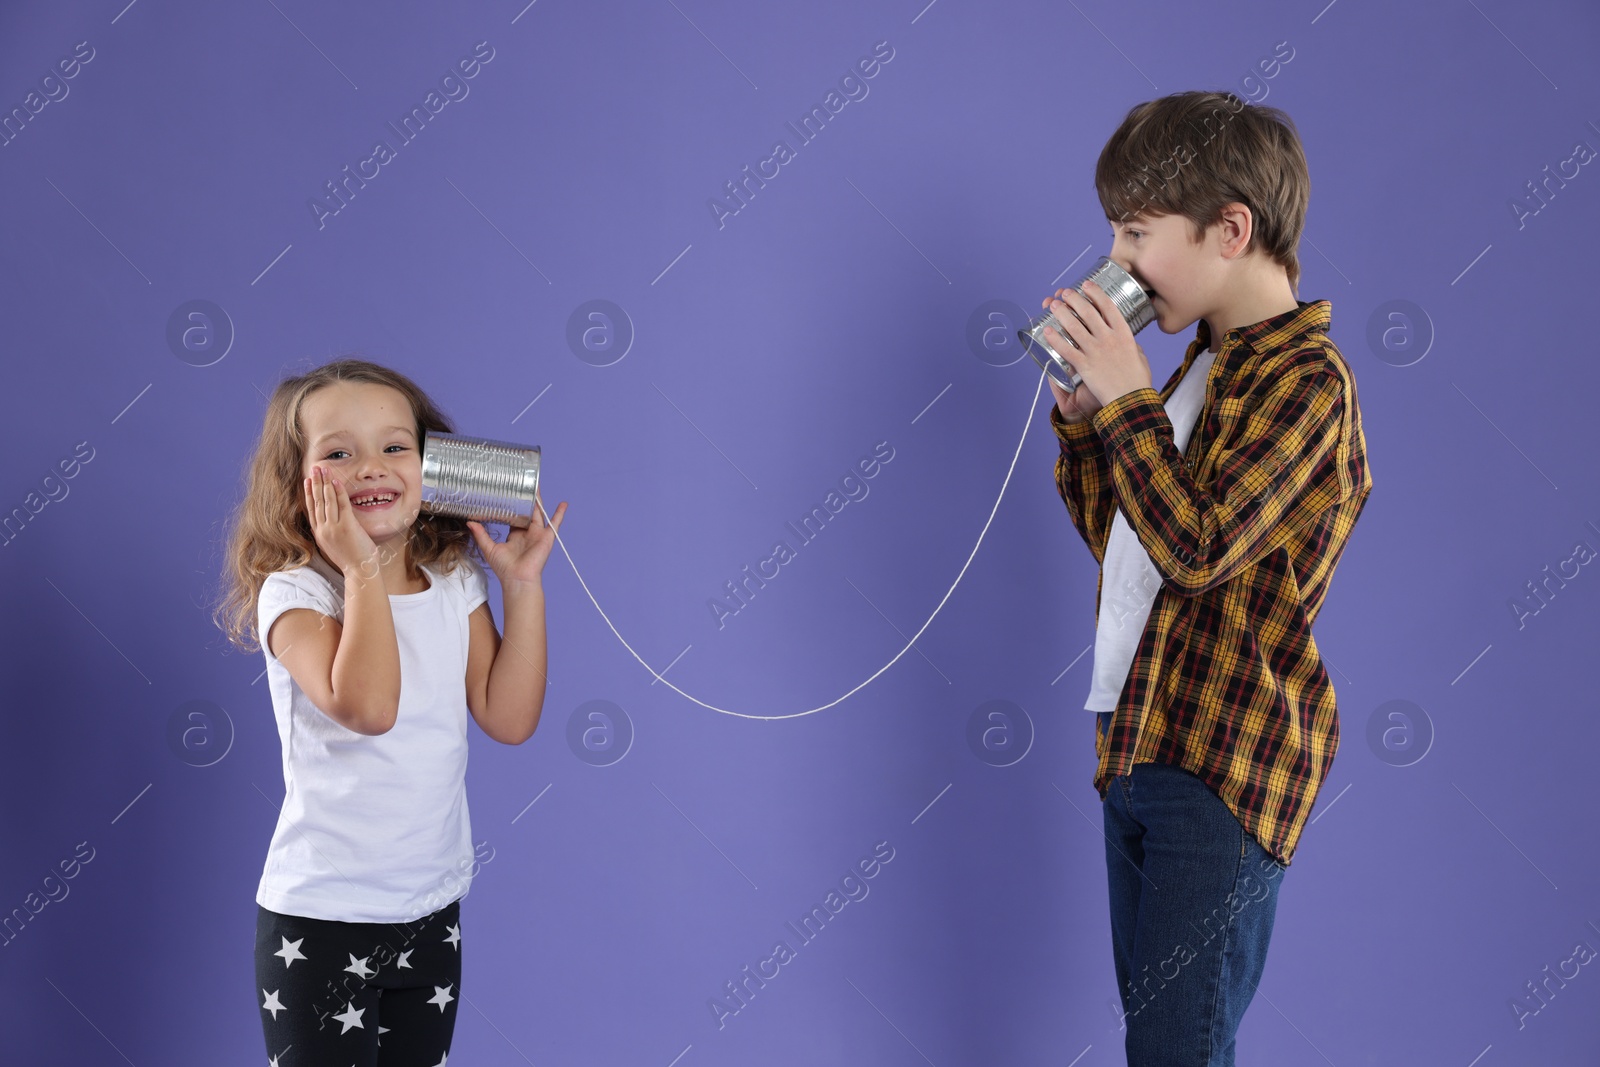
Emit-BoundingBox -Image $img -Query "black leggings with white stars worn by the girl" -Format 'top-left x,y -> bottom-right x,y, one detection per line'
256,901 -> 461,1067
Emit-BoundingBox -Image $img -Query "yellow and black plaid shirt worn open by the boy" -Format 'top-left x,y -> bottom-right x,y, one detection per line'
1050,301 -> 1373,865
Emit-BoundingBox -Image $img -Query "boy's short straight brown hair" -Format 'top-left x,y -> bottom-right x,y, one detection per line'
1094,90 -> 1310,294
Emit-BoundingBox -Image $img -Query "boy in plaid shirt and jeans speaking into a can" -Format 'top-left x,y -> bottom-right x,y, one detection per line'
1045,91 -> 1371,1067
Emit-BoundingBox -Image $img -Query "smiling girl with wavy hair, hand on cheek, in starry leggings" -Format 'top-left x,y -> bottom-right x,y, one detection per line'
216,360 -> 566,1067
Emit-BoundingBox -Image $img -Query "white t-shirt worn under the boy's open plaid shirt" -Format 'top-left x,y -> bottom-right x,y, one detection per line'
1083,350 -> 1216,712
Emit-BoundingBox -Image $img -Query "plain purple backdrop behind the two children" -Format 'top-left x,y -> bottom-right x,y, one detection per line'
0,0 -> 1600,1067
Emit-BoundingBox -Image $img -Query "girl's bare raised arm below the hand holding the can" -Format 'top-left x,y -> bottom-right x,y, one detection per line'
467,579 -> 549,745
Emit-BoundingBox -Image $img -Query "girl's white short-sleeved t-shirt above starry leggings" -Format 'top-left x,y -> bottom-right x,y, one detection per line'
256,553 -> 488,923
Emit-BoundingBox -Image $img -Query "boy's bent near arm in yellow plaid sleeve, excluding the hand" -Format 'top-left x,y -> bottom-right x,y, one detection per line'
1091,350 -> 1354,597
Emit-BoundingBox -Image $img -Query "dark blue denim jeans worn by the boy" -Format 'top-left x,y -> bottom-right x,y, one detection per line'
1102,751 -> 1285,1067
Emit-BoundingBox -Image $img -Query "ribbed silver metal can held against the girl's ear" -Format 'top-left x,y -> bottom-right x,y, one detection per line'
422,430 -> 539,526
